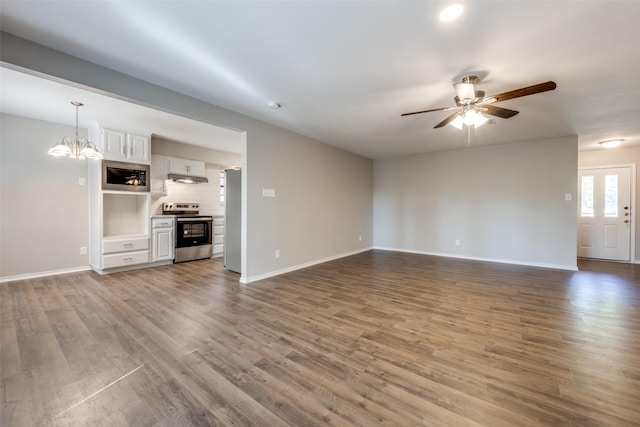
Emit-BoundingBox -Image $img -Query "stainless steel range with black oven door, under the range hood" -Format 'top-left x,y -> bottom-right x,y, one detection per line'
162,203 -> 213,262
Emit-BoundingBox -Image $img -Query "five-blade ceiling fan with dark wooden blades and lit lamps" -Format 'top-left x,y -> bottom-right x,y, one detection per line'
401,76 -> 556,129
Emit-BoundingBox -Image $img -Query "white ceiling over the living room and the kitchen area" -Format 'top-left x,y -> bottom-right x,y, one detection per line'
0,0 -> 640,159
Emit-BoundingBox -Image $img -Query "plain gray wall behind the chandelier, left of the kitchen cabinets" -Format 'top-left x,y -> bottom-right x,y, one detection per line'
0,114 -> 89,278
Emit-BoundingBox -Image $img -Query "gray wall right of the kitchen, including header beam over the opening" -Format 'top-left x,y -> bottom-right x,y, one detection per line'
0,33 -> 373,280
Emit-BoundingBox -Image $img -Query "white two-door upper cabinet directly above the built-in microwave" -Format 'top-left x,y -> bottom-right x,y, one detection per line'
101,129 -> 150,163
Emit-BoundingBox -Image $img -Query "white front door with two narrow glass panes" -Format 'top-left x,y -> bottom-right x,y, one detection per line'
578,167 -> 632,261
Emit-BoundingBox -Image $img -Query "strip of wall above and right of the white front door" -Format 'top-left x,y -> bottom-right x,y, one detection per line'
578,146 -> 640,261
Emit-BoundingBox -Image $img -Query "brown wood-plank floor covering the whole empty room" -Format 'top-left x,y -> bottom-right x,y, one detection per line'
0,251 -> 640,427
